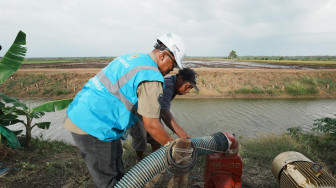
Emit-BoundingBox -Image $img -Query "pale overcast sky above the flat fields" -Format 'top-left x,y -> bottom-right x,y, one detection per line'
0,0 -> 336,57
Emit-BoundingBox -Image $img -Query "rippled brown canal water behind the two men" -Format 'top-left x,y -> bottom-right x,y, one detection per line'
9,99 -> 336,144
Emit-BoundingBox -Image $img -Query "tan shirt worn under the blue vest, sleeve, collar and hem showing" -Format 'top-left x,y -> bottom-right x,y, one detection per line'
64,52 -> 163,134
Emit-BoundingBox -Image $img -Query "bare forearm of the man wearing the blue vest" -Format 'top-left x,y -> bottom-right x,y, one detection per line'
142,116 -> 174,145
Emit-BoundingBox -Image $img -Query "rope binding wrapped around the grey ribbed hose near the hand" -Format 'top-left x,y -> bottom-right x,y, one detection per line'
164,141 -> 197,175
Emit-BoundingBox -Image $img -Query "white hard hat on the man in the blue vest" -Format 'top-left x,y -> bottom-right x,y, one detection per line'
157,33 -> 186,69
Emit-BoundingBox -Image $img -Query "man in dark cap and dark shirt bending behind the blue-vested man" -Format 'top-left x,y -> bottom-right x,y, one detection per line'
130,68 -> 198,162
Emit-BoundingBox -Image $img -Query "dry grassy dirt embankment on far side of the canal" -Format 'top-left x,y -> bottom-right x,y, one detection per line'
0,68 -> 336,99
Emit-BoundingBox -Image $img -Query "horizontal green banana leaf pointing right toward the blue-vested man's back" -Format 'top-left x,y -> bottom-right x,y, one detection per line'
33,99 -> 73,112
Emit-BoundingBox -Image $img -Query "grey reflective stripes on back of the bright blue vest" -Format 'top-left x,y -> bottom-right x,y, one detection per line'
97,65 -> 160,111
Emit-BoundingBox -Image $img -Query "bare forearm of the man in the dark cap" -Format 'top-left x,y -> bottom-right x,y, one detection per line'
160,109 -> 190,138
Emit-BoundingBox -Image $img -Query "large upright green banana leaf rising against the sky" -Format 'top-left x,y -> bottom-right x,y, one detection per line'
0,31 -> 27,84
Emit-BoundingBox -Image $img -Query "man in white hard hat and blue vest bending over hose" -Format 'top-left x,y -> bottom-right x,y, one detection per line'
64,33 -> 189,187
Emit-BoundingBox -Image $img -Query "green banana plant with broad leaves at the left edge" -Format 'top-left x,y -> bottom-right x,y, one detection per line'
0,31 -> 72,148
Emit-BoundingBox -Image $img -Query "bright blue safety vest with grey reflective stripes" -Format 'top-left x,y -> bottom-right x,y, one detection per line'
67,54 -> 164,141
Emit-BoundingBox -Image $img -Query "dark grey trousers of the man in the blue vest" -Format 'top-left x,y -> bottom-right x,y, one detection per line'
71,133 -> 125,188
